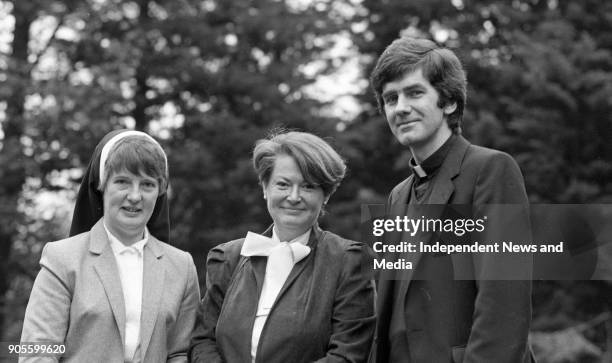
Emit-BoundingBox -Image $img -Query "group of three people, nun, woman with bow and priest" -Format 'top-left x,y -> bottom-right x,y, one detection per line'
21,34 -> 531,363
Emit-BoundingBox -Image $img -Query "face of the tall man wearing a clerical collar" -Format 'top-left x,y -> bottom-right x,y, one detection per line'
382,68 -> 457,162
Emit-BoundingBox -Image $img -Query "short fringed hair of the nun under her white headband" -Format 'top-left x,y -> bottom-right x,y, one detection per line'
98,135 -> 168,195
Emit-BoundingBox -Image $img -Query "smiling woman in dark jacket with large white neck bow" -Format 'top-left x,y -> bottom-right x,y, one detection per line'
190,132 -> 375,363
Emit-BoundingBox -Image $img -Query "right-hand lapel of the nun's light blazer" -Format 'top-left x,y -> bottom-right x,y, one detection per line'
140,234 -> 165,360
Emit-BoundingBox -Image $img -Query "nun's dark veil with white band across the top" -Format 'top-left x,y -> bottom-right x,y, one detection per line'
70,130 -> 170,242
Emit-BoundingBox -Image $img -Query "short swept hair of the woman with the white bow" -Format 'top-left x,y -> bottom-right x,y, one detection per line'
253,131 -> 346,196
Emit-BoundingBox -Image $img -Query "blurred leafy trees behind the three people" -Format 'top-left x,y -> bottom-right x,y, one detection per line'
0,0 -> 612,363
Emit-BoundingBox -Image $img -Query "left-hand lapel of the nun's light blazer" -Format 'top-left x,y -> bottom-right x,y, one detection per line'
89,219 -> 125,348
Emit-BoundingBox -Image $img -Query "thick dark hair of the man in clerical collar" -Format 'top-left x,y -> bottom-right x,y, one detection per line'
370,37 -> 467,134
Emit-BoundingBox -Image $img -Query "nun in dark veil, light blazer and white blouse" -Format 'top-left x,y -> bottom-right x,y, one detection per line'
20,130 -> 200,363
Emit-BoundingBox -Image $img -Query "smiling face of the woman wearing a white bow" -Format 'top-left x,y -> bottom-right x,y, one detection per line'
263,154 -> 328,241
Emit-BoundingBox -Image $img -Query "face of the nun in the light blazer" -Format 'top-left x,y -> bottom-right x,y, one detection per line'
103,170 -> 159,245
